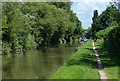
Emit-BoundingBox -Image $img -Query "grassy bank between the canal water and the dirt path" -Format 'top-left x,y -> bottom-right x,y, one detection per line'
51,40 -> 100,79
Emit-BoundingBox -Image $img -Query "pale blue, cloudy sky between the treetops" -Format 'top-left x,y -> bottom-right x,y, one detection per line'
71,0 -> 110,29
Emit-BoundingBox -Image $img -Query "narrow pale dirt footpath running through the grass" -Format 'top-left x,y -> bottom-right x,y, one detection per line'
92,41 -> 107,81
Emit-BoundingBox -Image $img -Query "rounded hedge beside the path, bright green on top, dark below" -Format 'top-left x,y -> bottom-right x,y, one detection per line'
96,26 -> 120,55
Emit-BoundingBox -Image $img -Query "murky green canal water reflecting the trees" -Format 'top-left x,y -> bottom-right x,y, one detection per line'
2,47 -> 77,79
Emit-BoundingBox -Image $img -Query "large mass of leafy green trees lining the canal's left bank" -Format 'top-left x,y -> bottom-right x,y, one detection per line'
2,2 -> 82,53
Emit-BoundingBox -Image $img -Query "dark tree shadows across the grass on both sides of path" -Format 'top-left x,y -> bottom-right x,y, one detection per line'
67,48 -> 118,68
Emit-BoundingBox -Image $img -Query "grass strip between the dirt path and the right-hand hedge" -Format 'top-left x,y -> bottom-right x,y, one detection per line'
95,40 -> 119,79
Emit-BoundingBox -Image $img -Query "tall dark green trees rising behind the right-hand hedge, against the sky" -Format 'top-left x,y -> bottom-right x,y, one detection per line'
92,5 -> 119,38
